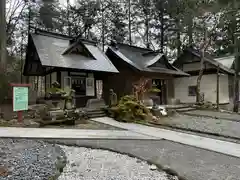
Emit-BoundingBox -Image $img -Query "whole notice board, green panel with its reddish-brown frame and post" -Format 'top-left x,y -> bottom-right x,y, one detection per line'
11,84 -> 30,123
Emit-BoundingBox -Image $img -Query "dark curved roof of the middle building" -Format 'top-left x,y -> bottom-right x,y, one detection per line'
106,43 -> 188,76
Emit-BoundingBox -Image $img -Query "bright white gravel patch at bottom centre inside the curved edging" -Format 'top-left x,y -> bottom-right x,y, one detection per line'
59,146 -> 177,180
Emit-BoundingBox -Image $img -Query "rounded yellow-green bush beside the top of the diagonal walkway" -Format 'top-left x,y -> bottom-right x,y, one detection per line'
108,96 -> 151,122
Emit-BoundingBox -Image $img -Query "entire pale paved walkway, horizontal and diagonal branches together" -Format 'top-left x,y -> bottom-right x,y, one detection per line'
0,117 -> 240,157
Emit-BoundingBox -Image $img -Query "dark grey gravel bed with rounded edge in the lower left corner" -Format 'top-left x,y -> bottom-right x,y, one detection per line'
0,139 -> 66,180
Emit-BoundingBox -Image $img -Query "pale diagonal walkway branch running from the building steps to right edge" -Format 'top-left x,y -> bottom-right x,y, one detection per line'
92,117 -> 240,157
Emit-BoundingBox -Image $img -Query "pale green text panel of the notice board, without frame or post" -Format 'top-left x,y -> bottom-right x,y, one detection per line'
13,87 -> 28,111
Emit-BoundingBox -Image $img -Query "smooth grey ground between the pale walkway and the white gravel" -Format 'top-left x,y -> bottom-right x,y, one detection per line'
47,140 -> 240,180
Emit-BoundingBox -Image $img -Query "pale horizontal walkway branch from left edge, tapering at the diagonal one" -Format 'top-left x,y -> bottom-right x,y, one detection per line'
0,128 -> 157,139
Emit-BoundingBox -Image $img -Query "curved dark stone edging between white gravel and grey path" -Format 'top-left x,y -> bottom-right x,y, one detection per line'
45,139 -> 187,180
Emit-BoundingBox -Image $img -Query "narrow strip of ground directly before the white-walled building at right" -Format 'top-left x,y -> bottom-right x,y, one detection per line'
183,110 -> 240,122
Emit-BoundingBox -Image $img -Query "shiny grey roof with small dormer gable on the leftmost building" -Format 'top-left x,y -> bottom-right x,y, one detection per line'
24,31 -> 118,73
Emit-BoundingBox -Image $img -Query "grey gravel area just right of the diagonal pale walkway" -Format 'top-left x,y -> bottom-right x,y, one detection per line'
158,114 -> 240,138
